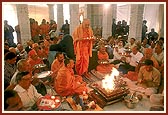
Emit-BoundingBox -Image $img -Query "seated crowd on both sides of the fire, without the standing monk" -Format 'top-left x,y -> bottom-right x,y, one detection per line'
4,20 -> 164,111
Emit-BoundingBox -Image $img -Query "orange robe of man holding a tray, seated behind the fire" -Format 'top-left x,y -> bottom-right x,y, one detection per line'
96,51 -> 114,73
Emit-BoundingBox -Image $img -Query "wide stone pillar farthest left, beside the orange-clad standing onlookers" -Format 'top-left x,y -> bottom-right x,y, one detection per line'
16,4 -> 31,46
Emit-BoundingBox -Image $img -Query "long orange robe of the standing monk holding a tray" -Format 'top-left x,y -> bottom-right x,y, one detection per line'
73,25 -> 93,75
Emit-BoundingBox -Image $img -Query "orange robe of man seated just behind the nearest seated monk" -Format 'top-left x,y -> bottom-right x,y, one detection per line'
51,59 -> 64,79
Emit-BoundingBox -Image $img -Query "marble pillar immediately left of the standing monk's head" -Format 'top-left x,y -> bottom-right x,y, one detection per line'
69,4 -> 80,35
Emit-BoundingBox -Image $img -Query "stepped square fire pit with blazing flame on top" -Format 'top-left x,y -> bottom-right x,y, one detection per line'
89,68 -> 129,108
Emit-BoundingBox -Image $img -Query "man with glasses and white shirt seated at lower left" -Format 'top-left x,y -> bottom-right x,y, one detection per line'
14,72 -> 42,110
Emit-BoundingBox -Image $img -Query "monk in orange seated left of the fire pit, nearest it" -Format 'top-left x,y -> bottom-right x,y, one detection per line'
54,58 -> 88,110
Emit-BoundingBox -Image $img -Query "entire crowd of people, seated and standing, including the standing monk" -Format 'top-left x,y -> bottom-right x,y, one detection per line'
3,18 -> 164,110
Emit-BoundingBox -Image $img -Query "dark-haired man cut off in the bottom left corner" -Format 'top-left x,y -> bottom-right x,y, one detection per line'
4,90 -> 23,111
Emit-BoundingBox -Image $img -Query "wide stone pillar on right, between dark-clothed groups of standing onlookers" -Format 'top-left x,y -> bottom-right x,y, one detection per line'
128,4 -> 144,41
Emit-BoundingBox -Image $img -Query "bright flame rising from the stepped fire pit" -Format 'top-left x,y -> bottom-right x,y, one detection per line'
102,67 -> 119,92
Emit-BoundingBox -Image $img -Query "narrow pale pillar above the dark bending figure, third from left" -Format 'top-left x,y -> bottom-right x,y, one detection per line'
57,4 -> 64,33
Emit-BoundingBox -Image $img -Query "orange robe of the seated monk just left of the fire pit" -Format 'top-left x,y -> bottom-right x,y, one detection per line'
54,66 -> 87,96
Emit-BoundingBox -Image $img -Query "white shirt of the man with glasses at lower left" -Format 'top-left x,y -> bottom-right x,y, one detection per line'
14,84 -> 42,110
